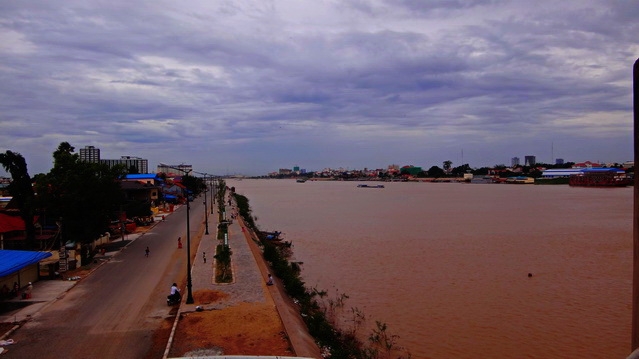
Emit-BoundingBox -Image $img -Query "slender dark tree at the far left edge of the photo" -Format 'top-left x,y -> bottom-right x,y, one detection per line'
0,151 -> 36,250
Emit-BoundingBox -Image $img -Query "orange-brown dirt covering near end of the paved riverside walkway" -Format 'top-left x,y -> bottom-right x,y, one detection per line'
169,291 -> 294,357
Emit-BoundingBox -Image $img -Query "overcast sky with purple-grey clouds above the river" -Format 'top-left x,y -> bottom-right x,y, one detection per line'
0,0 -> 639,176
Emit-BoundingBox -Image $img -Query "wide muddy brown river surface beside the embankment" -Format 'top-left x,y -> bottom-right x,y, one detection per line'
227,179 -> 633,359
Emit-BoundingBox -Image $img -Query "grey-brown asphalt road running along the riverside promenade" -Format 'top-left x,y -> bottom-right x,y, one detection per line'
3,197 -> 204,359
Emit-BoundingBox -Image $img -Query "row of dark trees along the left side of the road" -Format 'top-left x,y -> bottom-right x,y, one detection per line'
0,142 -> 206,249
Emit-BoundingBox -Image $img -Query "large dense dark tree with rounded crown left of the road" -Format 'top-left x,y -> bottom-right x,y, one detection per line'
36,142 -> 124,249
